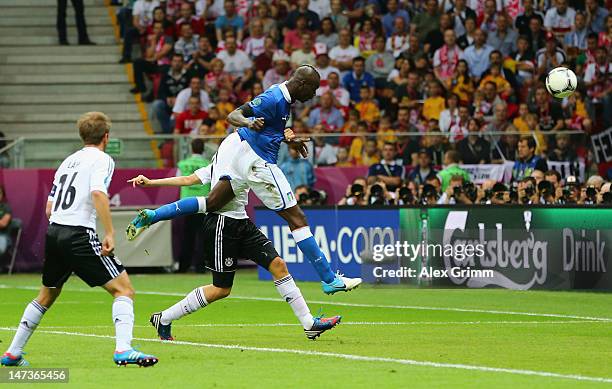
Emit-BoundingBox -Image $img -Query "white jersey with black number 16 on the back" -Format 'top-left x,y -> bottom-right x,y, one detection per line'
49,147 -> 115,230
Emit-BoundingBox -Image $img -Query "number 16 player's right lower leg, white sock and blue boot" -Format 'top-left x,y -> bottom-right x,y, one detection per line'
103,271 -> 158,367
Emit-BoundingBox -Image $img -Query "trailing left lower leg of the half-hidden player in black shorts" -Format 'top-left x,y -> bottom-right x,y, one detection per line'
149,277 -> 232,340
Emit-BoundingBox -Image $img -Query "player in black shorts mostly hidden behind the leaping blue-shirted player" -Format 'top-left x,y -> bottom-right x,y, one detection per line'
129,152 -> 342,340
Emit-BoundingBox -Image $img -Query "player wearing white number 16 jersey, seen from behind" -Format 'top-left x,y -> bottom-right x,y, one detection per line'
1,112 -> 158,366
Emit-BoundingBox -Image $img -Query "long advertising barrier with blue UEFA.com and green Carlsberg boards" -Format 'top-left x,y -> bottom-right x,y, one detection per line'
255,205 -> 612,290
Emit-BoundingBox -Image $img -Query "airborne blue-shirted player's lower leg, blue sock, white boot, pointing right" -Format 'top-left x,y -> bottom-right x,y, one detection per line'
278,205 -> 361,294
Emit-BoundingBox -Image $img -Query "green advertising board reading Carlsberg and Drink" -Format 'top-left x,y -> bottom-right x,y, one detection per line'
398,206 -> 612,289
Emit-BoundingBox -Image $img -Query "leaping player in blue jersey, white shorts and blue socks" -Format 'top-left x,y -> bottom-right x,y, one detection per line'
127,65 -> 361,294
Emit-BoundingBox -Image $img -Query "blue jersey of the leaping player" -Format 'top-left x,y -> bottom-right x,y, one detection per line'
238,83 -> 291,164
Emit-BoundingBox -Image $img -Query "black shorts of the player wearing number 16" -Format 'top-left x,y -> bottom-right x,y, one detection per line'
42,224 -> 124,288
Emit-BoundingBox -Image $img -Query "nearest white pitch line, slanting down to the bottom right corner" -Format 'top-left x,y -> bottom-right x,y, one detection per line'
0,327 -> 612,383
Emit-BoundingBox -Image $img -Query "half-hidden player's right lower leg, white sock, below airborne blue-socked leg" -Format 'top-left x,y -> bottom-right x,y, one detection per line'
268,257 -> 342,340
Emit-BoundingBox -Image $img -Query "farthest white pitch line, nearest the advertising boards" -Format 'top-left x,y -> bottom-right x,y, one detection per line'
0,284 -> 612,322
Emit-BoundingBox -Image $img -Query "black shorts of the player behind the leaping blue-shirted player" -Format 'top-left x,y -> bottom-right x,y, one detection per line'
204,213 -> 279,288
